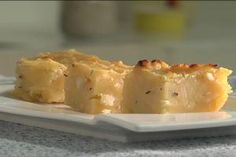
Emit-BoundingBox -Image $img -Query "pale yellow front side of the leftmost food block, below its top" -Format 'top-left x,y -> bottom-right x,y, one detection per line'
14,58 -> 66,103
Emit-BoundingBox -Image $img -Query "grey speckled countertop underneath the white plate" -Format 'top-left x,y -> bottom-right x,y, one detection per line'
0,121 -> 236,157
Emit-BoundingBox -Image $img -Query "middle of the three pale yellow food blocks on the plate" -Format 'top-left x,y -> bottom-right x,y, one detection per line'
65,60 -> 131,114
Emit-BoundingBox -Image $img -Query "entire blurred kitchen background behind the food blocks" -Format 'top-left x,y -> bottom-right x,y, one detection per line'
0,0 -> 236,76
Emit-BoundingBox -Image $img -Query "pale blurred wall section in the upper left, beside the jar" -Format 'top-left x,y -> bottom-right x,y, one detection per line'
0,1 -> 61,31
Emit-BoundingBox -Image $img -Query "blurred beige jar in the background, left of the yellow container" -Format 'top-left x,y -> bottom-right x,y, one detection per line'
61,1 -> 118,38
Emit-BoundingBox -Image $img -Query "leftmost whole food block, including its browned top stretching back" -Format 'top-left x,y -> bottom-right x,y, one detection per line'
14,50 -> 105,103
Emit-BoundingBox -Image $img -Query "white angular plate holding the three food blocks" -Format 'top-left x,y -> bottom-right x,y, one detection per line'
0,81 -> 236,142
